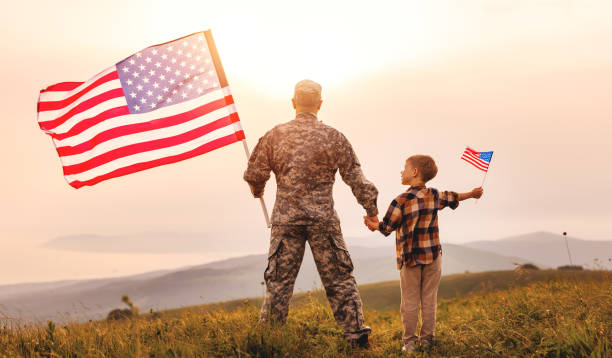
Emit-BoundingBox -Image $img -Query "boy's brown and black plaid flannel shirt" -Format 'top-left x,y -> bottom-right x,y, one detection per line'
378,186 -> 459,270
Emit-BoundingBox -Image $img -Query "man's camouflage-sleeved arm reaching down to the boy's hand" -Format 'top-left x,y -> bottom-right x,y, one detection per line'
337,132 -> 378,217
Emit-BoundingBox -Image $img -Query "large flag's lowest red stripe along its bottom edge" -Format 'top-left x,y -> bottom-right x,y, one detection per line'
69,131 -> 245,189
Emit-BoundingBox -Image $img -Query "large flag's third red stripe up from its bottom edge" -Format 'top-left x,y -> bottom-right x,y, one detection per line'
57,98 -> 234,157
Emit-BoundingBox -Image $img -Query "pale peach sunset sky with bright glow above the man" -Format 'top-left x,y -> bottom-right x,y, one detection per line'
0,0 -> 612,284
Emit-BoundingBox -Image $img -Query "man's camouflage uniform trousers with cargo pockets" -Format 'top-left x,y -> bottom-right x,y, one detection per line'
261,224 -> 371,339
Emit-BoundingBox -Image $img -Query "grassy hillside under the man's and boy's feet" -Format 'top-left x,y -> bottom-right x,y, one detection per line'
0,271 -> 612,357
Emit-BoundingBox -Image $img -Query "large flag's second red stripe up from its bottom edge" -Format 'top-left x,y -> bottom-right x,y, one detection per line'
64,116 -> 239,175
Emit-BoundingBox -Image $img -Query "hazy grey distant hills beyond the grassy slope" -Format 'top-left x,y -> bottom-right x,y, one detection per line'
0,233 -> 612,321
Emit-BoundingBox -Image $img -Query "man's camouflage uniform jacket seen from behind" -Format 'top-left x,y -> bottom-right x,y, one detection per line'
244,113 -> 378,225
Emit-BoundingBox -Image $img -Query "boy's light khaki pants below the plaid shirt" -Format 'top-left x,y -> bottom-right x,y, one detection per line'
400,255 -> 442,343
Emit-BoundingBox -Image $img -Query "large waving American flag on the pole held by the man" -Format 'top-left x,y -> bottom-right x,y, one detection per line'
38,31 -> 244,188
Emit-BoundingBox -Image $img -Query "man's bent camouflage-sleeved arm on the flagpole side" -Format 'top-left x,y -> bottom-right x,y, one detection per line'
243,132 -> 272,198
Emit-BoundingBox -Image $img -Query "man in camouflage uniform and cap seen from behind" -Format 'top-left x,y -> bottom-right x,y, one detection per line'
244,80 -> 378,346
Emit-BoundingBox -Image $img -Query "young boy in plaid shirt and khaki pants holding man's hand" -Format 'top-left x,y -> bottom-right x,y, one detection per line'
364,155 -> 482,352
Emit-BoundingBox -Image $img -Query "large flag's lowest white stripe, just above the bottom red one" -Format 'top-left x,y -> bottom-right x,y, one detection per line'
65,126 -> 235,183
